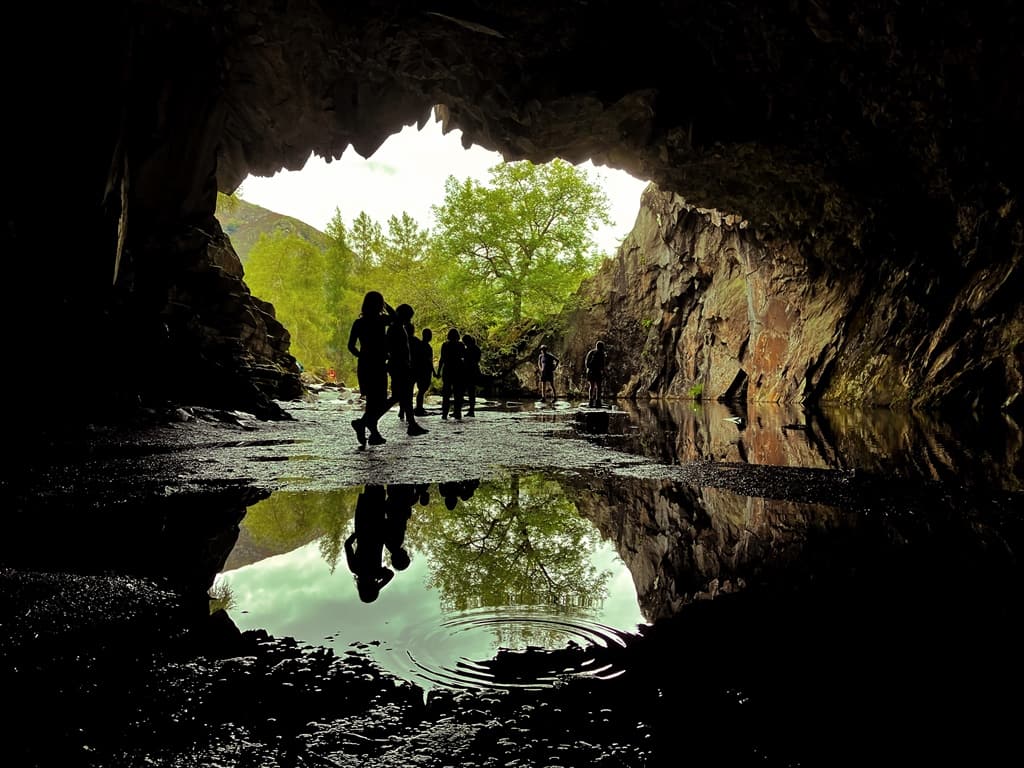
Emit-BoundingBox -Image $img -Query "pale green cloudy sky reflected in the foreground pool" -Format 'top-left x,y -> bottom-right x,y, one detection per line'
217,542 -> 644,678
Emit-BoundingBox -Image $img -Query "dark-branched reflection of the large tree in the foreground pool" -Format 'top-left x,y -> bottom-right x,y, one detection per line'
417,475 -> 610,610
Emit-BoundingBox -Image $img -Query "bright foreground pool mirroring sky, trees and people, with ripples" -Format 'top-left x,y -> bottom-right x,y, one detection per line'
214,474 -> 644,689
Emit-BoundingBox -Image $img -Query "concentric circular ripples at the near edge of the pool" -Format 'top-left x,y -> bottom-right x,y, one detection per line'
379,607 -> 637,689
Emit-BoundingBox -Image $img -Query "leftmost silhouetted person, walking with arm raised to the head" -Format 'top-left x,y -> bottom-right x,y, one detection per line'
348,291 -> 394,447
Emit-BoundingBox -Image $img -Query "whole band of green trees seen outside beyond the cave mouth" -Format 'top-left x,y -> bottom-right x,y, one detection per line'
218,160 -> 609,381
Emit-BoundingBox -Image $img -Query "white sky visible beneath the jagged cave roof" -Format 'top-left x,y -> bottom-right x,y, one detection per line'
239,114 -> 647,255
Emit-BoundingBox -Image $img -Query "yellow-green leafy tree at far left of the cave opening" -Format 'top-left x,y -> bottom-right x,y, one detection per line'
245,232 -> 335,369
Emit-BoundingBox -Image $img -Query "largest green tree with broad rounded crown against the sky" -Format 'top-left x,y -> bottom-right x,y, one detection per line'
433,160 -> 609,325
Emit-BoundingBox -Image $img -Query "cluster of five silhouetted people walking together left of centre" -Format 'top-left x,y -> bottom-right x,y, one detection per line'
348,291 -> 481,447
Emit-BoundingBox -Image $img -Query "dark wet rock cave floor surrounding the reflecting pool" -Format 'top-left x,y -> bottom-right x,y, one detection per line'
0,391 -> 1021,766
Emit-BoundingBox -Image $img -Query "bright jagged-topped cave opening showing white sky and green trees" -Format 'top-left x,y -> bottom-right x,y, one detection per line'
217,112 -> 647,386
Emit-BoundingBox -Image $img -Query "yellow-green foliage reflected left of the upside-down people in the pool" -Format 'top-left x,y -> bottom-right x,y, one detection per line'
242,487 -> 361,571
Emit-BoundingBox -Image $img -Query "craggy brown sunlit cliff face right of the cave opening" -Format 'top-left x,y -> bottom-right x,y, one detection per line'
563,186 -> 1024,410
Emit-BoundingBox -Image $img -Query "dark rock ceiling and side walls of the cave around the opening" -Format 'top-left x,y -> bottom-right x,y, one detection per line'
0,0 -> 1024,429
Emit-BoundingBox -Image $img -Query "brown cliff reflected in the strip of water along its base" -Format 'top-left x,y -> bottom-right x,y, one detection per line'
598,400 -> 1024,492
